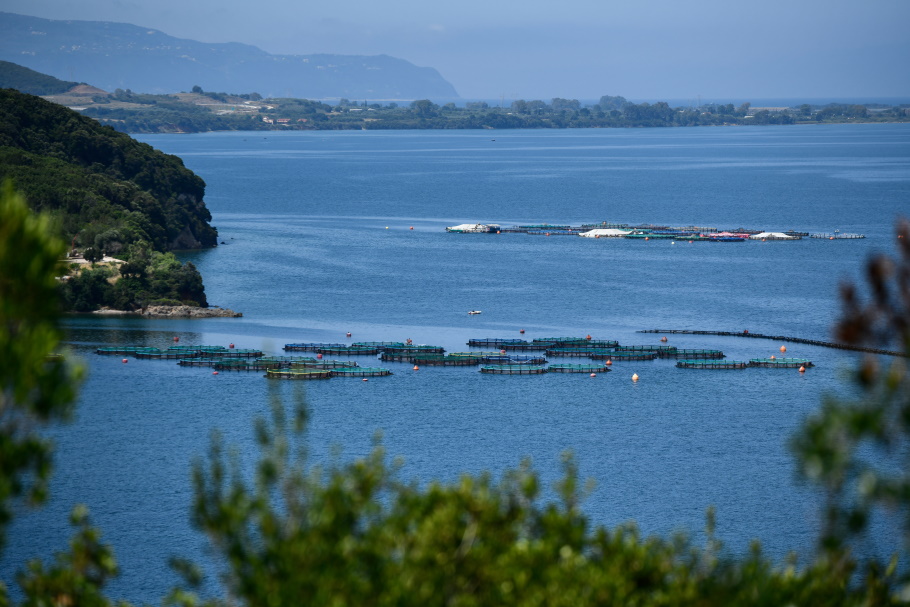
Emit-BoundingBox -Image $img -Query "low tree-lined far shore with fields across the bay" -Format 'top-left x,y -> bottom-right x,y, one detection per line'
51,86 -> 910,133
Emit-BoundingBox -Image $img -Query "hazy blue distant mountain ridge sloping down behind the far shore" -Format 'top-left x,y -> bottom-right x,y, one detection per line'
0,12 -> 458,100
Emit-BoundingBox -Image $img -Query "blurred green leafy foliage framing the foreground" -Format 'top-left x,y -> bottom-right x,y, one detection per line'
0,183 -> 910,607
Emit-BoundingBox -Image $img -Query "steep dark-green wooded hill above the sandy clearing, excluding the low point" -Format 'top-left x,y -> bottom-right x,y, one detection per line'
0,89 -> 218,254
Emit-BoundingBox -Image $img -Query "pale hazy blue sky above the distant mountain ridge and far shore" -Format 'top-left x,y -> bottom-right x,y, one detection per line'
7,0 -> 910,101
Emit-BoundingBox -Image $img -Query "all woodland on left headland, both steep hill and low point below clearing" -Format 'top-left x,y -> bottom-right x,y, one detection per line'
0,89 -> 218,311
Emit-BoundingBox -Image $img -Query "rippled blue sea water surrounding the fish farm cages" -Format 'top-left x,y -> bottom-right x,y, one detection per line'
0,124 -> 910,602
